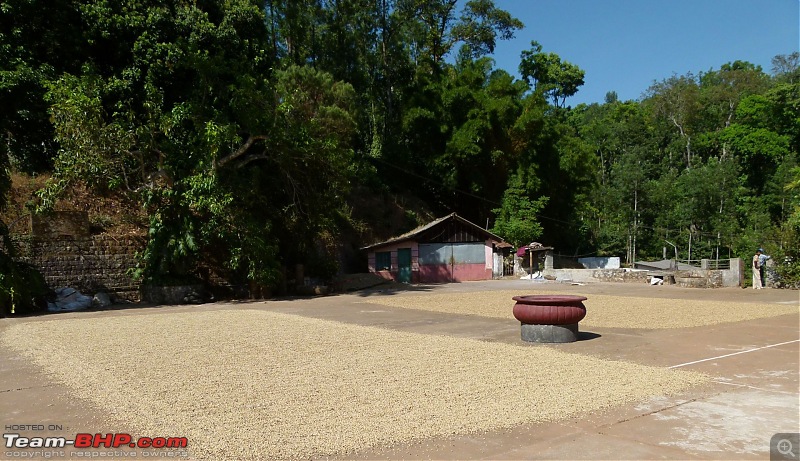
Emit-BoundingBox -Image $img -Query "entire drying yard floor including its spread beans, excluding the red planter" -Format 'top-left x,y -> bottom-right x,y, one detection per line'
0,280 -> 800,459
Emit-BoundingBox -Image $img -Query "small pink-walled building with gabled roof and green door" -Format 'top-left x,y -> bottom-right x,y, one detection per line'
362,213 -> 503,283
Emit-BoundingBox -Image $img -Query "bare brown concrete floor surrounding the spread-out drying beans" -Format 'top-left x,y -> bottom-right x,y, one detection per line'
0,280 -> 800,459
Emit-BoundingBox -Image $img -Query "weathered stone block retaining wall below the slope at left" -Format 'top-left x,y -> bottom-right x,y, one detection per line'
14,235 -> 146,301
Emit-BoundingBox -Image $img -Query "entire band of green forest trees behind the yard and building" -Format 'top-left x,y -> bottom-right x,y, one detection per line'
0,0 -> 800,285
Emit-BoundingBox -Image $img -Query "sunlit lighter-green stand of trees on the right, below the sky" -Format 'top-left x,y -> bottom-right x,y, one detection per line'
575,56 -> 798,279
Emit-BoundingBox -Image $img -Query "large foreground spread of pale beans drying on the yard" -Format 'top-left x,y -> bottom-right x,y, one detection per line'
2,310 -> 706,459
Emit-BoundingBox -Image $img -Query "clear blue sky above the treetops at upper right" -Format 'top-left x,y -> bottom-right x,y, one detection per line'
492,0 -> 800,106
